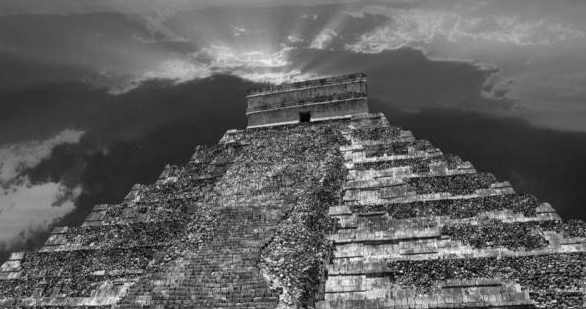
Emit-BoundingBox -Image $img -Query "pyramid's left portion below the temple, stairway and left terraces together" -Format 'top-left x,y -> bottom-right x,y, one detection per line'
0,120 -> 348,308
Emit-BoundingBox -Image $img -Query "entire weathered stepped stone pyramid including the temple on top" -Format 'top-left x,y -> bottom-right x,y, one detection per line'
0,74 -> 586,309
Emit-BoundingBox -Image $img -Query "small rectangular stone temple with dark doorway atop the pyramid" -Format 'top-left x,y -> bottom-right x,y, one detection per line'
246,73 -> 368,128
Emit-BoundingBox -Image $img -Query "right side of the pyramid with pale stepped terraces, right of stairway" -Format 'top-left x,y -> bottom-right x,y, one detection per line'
317,111 -> 586,309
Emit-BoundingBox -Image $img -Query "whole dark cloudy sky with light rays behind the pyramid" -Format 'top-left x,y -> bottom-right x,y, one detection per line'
0,0 -> 586,259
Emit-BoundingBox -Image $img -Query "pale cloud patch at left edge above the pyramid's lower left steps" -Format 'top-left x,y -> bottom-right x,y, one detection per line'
0,130 -> 84,250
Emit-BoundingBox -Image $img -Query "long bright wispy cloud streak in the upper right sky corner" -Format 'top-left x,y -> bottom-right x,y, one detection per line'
346,6 -> 585,53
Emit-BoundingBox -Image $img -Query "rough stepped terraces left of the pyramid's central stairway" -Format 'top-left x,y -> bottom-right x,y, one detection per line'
0,142 -> 240,306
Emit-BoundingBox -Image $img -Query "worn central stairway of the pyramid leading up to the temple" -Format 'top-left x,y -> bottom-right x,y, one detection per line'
116,121 -> 346,308
